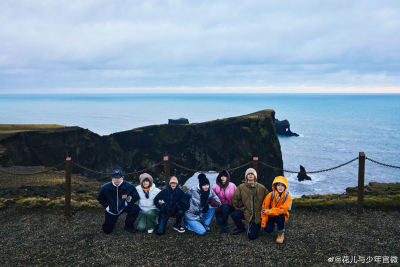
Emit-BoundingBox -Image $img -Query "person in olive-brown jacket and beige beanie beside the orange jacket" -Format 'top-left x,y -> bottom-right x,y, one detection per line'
231,168 -> 268,239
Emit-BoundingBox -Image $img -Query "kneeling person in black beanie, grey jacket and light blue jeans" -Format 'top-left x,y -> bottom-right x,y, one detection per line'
185,173 -> 221,235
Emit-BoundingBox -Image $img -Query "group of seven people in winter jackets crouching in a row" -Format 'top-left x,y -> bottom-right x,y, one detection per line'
97,168 -> 292,243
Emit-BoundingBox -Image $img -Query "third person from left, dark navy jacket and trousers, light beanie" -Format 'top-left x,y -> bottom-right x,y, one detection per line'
154,176 -> 189,235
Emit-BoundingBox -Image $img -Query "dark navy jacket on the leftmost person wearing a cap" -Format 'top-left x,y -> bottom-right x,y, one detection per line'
97,181 -> 139,214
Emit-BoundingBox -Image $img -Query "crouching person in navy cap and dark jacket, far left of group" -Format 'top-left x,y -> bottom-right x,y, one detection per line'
97,170 -> 140,234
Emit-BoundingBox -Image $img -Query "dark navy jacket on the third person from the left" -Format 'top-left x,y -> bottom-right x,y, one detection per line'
154,176 -> 190,215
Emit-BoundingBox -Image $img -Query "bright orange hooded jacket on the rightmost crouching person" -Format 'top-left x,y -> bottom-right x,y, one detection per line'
261,176 -> 292,227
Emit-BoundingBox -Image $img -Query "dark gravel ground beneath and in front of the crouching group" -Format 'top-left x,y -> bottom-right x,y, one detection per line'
0,208 -> 400,267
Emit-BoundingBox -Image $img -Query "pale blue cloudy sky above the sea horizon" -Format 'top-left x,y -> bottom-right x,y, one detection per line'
0,0 -> 400,94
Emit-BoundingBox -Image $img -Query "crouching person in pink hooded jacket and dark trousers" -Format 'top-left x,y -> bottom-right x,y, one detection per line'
210,170 -> 236,233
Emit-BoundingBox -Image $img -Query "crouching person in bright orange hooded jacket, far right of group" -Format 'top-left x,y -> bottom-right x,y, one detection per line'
261,176 -> 292,244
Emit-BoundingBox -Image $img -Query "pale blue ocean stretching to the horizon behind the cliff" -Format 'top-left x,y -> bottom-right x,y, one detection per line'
0,94 -> 400,197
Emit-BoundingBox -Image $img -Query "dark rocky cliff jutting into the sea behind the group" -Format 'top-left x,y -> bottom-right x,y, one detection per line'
0,110 -> 283,187
